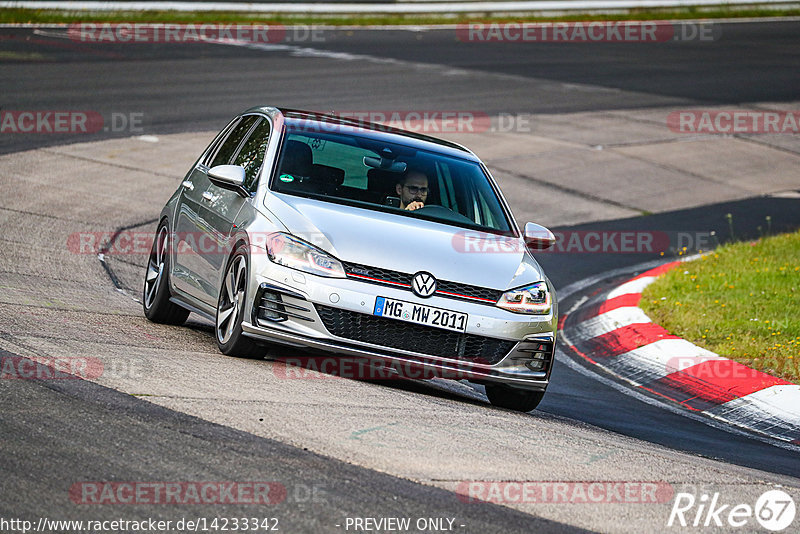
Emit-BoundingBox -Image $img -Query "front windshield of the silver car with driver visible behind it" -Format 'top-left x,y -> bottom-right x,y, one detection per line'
271,128 -> 513,234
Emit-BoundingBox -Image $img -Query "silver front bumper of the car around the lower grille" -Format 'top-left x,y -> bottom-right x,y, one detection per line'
242,262 -> 557,391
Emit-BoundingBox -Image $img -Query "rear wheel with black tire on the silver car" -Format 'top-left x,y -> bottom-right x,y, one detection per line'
142,221 -> 189,325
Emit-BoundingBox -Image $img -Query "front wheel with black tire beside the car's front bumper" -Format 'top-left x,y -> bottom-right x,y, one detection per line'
214,245 -> 266,358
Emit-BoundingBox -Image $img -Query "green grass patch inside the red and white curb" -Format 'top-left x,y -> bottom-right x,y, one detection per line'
640,232 -> 800,384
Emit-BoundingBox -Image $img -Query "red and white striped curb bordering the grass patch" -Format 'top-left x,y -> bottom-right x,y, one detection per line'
561,261 -> 800,445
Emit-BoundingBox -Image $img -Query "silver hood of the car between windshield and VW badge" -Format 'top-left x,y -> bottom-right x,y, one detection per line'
265,193 -> 545,290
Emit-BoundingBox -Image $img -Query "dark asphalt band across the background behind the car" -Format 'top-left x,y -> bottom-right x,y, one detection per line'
0,22 -> 800,153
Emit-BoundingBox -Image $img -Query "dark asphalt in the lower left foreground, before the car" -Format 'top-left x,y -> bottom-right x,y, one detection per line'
0,346 -> 582,532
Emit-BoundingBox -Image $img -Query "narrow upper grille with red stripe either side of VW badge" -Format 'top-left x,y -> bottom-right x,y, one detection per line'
342,262 -> 503,306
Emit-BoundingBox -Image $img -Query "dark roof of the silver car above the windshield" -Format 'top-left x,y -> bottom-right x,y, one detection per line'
243,106 -> 480,163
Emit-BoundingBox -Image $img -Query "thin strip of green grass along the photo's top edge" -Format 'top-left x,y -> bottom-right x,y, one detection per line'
0,7 -> 800,26
